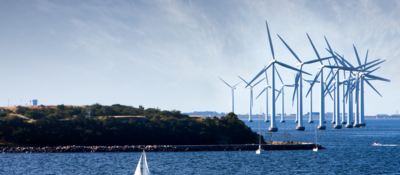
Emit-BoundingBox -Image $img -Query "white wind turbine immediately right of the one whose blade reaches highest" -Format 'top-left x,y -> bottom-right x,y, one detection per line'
278,33 -> 332,131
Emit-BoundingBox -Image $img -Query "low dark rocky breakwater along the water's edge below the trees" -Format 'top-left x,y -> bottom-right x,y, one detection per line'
0,143 -> 325,153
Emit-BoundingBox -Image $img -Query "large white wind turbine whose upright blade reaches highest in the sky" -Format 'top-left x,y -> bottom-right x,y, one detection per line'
247,21 -> 311,132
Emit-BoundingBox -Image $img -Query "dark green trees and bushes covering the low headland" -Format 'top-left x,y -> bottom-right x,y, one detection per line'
0,104 -> 263,146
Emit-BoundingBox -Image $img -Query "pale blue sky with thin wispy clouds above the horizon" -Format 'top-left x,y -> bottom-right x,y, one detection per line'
0,0 -> 400,115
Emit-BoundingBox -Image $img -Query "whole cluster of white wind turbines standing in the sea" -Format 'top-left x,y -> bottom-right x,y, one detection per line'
220,21 -> 390,132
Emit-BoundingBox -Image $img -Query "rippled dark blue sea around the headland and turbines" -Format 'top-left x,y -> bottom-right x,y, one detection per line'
0,119 -> 400,174
